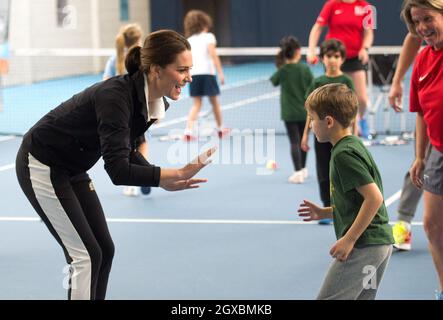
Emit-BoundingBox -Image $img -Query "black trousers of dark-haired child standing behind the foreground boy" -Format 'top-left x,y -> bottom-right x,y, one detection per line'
314,137 -> 332,207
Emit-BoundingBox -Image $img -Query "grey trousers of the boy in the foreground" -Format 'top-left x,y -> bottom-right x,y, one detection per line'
317,245 -> 392,300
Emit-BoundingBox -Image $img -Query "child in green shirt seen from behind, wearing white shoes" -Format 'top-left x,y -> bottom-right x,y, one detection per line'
270,36 -> 314,183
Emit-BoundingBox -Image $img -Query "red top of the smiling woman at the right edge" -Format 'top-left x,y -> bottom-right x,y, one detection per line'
409,46 -> 443,152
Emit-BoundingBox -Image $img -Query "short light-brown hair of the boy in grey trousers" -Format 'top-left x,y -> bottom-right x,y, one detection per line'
305,83 -> 358,128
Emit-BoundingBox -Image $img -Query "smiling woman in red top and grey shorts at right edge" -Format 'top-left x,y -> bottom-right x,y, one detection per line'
402,0 -> 443,300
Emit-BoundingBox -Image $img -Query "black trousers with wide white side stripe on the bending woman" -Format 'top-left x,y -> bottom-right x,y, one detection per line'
16,145 -> 114,300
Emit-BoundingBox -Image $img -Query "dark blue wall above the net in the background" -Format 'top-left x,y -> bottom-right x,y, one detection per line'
151,0 -> 407,47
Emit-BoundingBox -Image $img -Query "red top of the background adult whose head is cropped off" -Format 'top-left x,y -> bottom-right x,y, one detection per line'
317,0 -> 374,58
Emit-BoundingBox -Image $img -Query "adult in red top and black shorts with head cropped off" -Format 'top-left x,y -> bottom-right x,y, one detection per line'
307,0 -> 374,137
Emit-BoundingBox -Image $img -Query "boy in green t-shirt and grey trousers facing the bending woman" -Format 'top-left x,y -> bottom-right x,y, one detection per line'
298,84 -> 394,300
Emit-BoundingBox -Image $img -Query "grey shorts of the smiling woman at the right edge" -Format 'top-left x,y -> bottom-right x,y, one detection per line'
423,147 -> 443,195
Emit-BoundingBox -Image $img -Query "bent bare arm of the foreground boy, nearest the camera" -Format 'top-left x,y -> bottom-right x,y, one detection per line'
330,183 -> 383,261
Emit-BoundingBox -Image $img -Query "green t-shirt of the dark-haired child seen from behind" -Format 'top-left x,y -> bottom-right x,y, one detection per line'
270,62 -> 314,121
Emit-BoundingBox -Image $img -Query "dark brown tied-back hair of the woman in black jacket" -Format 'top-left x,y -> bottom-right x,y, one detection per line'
125,30 -> 191,75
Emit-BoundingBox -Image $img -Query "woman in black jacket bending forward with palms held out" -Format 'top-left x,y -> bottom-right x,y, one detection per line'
16,30 -> 214,299
